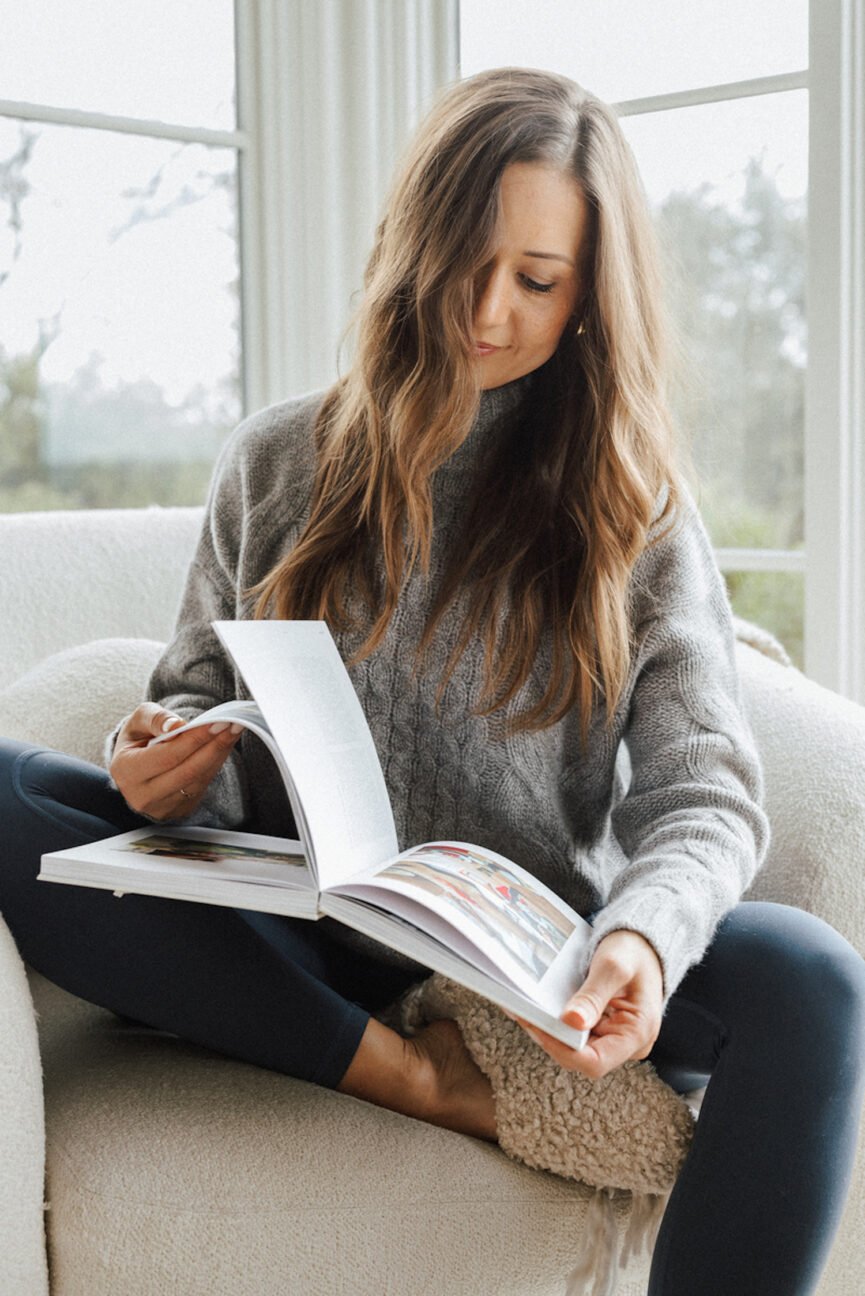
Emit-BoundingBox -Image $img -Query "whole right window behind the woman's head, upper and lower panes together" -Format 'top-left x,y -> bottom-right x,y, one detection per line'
460,0 -> 808,662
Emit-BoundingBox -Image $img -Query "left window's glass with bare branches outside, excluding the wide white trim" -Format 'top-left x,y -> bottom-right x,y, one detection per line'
0,0 -> 241,511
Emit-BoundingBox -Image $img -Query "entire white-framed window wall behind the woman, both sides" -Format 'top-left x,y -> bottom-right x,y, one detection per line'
0,0 -> 865,701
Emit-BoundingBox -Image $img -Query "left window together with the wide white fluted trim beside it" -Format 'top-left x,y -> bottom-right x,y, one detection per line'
0,0 -> 456,509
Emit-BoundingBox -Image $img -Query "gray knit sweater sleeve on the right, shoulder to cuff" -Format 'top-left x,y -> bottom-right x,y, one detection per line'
591,499 -> 769,997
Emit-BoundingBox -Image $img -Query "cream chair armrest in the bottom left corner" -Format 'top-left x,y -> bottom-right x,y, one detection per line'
0,918 -> 48,1296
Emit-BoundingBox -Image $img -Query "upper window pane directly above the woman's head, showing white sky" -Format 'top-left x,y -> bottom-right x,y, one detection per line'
459,0 -> 808,102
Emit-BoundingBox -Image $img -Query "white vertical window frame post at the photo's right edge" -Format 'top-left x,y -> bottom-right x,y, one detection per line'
805,0 -> 865,701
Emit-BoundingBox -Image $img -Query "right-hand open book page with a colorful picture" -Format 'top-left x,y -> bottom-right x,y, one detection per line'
338,841 -> 591,1013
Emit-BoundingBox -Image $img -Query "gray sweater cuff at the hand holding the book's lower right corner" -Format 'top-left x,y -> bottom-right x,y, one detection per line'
589,886 -> 708,1006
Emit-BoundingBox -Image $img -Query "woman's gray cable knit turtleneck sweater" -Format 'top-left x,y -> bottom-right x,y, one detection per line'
143,380 -> 768,995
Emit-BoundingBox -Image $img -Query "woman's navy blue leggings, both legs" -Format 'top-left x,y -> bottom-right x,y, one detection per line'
0,743 -> 865,1296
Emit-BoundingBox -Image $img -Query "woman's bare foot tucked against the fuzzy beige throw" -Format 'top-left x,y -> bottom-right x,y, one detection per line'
406,1021 -> 497,1143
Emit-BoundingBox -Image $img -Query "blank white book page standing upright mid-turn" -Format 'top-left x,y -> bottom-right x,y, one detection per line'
214,621 -> 398,890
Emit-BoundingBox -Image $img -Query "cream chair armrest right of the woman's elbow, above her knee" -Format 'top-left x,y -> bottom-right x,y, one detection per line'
737,644 -> 865,955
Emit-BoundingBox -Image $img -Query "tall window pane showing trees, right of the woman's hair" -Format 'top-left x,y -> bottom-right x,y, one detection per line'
622,91 -> 808,548
